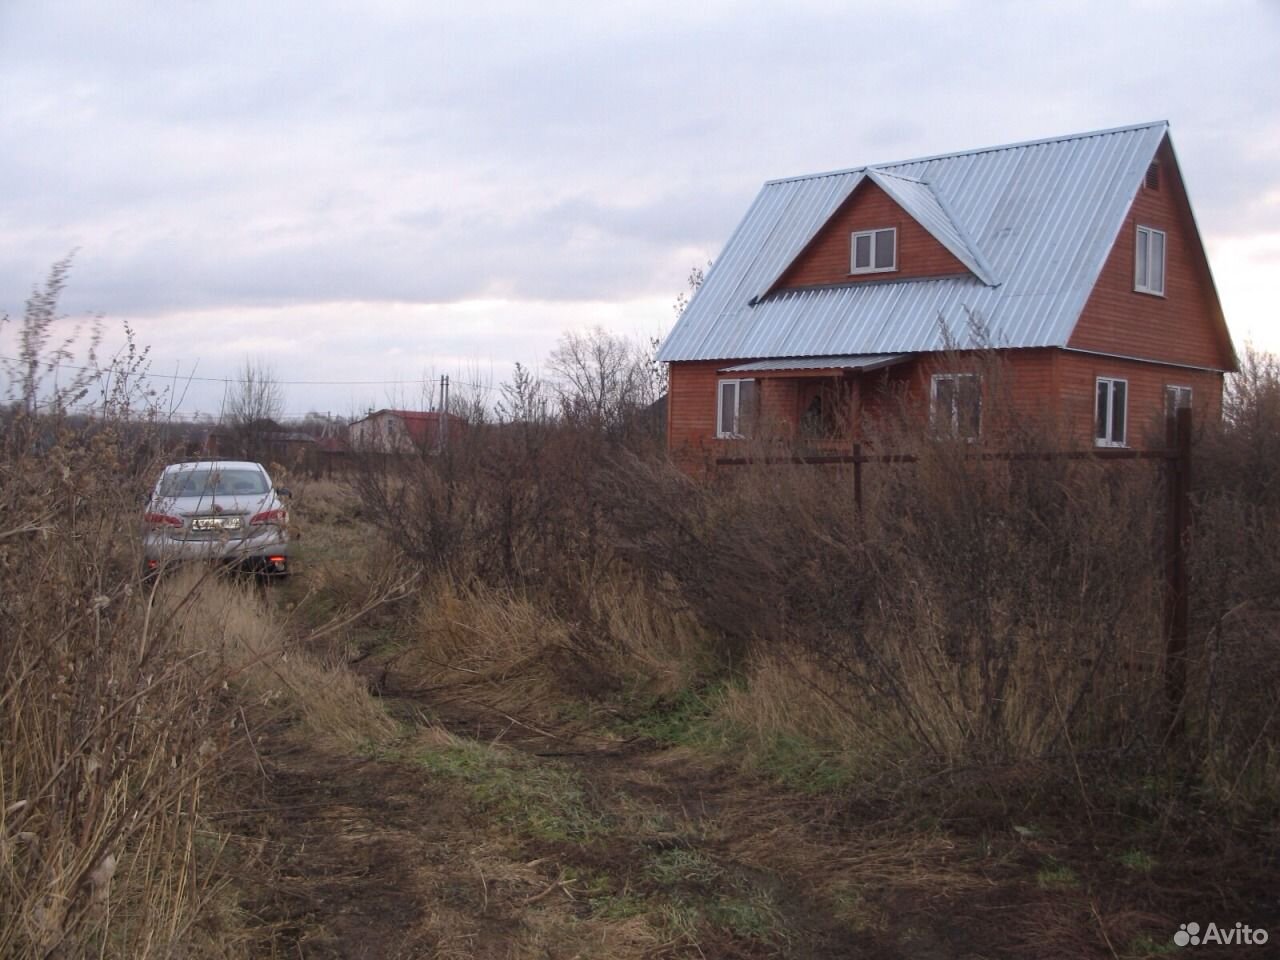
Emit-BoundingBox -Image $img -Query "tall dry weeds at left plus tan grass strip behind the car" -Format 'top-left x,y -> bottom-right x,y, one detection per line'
0,419 -> 396,960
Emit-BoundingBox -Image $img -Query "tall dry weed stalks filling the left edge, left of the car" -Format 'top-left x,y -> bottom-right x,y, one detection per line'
0,419 -> 234,957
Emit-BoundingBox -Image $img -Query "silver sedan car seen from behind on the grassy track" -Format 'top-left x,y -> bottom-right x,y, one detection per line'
142,460 -> 289,576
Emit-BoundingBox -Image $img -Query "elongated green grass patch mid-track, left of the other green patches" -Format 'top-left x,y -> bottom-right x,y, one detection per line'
412,737 -> 609,842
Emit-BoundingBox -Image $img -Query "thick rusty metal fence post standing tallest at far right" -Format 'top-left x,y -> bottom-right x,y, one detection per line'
1164,407 -> 1192,741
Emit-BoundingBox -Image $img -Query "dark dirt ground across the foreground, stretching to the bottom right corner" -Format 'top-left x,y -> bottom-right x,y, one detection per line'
215,650 -> 1274,960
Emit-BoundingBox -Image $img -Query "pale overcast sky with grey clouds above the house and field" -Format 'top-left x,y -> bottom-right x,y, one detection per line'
0,0 -> 1280,413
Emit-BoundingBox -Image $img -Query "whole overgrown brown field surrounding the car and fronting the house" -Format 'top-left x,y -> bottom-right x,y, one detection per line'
0,350 -> 1280,960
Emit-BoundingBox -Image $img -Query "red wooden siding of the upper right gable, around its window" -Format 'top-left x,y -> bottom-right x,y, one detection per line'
1069,140 -> 1235,370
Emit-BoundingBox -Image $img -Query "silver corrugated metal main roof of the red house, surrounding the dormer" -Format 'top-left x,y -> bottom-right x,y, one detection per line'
658,122 -> 1169,361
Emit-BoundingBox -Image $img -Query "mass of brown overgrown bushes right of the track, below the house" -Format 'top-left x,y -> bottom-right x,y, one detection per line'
361,357 -> 1280,824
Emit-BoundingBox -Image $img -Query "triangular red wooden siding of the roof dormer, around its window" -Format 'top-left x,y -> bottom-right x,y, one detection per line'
774,180 -> 968,289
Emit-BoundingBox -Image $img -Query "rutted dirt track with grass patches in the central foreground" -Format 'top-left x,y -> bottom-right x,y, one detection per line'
229,670 -> 1018,960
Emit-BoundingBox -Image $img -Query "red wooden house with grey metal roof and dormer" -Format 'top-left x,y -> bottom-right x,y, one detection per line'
658,123 -> 1236,463
